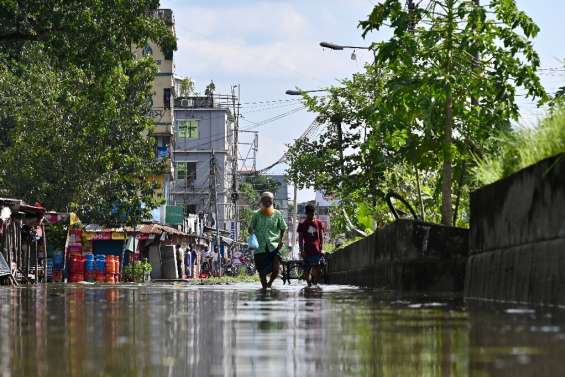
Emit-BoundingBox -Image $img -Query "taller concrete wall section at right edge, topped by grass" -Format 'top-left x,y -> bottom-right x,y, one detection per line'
465,154 -> 565,305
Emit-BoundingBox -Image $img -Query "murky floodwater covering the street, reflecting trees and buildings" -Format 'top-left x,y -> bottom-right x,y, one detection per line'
0,283 -> 565,377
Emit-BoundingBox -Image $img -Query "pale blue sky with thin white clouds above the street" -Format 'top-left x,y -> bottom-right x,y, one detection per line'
161,0 -> 565,201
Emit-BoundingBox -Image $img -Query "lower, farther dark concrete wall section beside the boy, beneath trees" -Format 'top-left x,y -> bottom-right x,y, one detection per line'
327,220 -> 468,291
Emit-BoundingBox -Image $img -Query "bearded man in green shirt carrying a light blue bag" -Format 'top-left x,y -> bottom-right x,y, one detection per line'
249,192 -> 287,290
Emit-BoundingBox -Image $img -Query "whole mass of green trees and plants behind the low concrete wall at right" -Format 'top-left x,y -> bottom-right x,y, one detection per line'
287,0 -> 548,237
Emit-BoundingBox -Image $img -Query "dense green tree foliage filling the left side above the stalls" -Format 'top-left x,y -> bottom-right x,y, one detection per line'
0,0 -> 176,225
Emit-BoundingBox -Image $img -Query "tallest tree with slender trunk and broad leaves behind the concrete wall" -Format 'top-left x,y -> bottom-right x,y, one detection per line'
360,0 -> 547,225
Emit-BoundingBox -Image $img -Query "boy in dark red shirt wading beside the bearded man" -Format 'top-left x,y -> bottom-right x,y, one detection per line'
297,204 -> 324,287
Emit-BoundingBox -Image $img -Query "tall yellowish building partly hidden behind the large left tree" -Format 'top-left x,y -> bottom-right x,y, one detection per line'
134,9 -> 175,224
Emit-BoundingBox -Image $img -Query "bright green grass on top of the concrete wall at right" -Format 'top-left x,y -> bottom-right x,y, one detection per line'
475,104 -> 565,185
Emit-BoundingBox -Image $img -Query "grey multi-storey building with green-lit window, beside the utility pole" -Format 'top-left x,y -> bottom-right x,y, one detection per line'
171,95 -> 235,230
